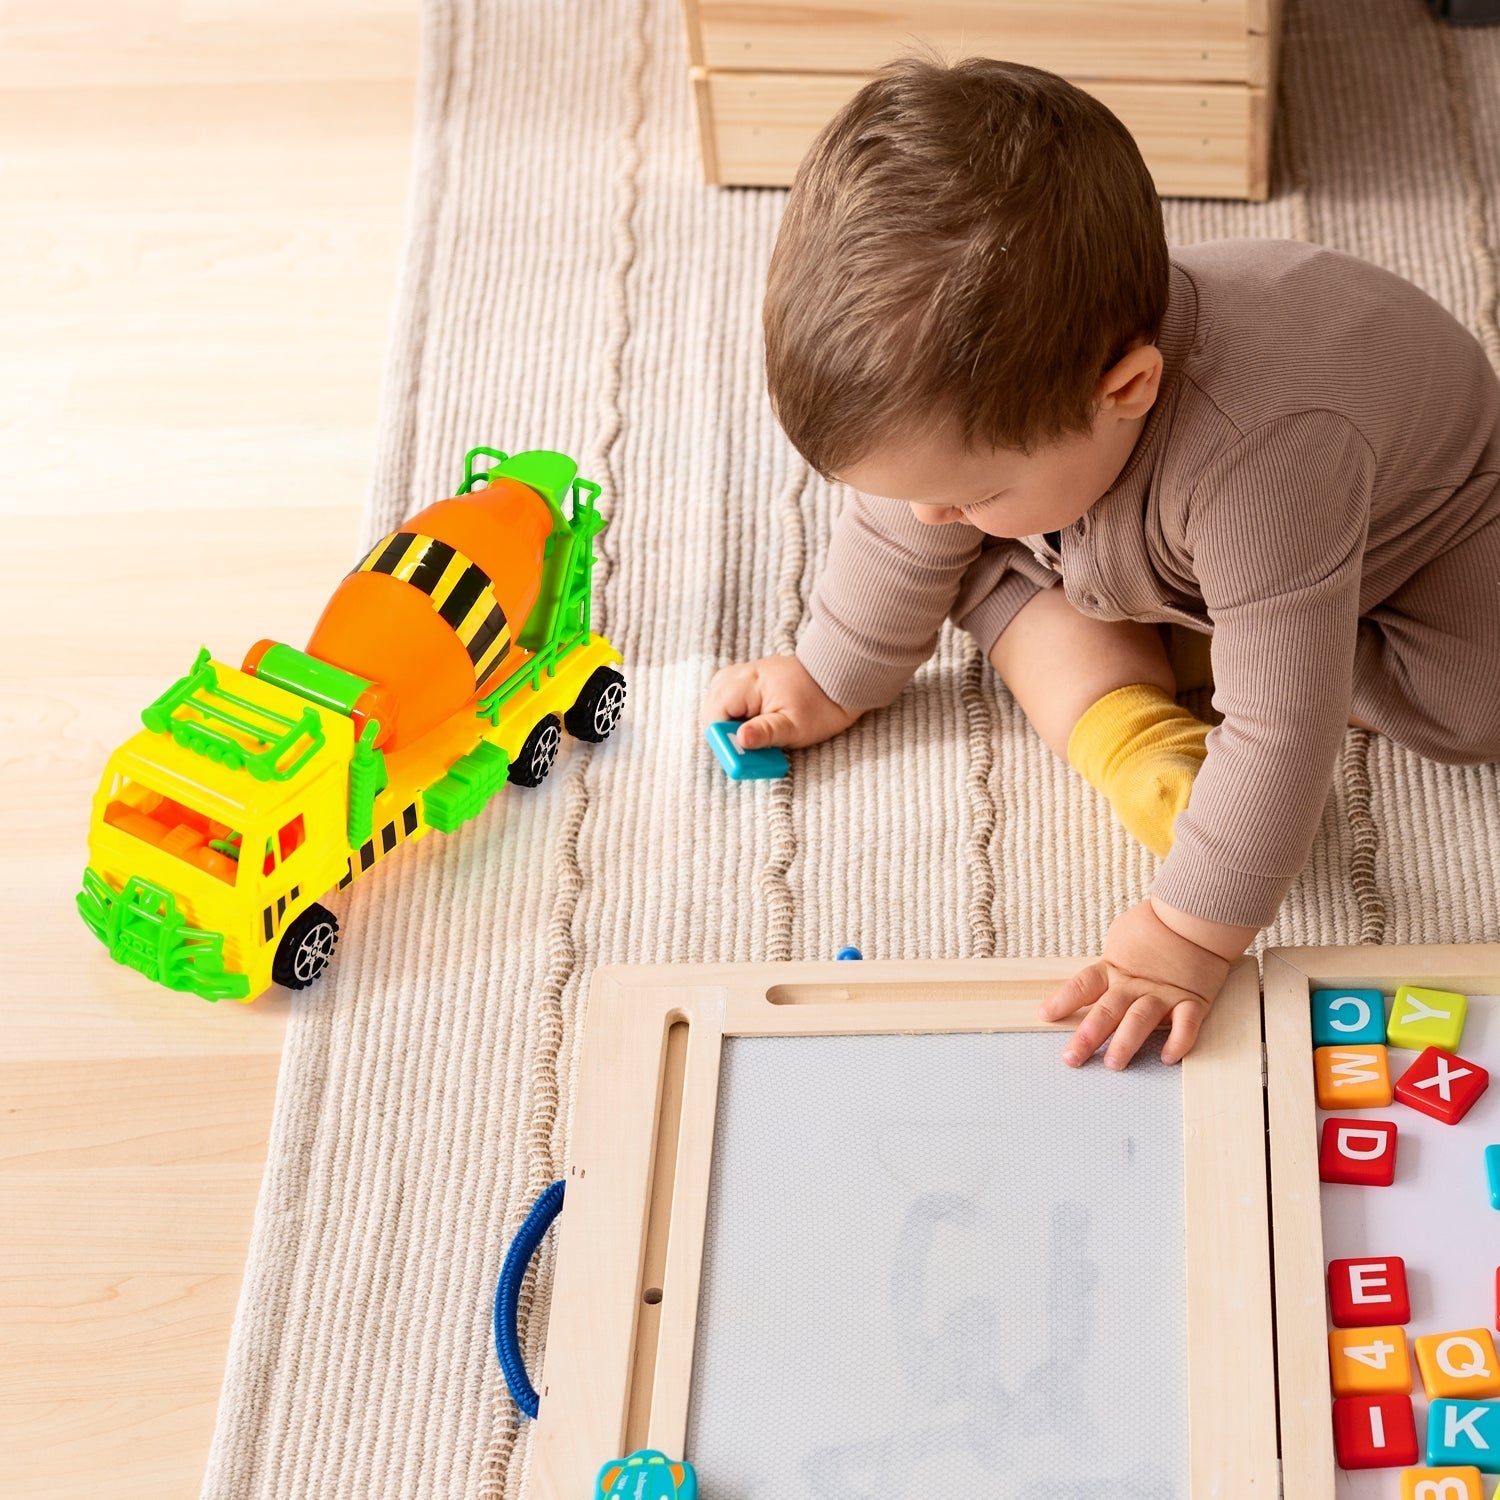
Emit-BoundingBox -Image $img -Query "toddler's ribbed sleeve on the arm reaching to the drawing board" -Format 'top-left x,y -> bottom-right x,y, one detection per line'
1152,411 -> 1374,927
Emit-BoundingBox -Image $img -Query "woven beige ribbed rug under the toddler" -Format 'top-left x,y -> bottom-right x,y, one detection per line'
204,0 -> 1500,1500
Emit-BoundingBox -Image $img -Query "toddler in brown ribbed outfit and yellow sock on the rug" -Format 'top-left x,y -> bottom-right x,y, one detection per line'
705,59 -> 1500,1067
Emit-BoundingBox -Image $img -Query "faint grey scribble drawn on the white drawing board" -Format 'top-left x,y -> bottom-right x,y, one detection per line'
803,1194 -> 1176,1500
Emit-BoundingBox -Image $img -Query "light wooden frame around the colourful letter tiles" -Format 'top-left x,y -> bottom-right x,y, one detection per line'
1262,944 -> 1500,1500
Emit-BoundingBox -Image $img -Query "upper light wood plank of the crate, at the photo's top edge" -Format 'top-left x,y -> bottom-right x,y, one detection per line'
689,0 -> 1251,83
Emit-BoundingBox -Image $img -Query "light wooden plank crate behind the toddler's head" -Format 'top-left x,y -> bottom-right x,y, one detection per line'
683,0 -> 1281,200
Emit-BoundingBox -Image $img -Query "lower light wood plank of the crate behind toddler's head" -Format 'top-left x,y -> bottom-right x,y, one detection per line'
702,71 -> 1257,198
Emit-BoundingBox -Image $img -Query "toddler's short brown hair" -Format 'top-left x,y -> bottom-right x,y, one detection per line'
764,57 -> 1169,476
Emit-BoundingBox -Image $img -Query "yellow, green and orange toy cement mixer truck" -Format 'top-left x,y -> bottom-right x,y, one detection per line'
78,449 -> 626,1001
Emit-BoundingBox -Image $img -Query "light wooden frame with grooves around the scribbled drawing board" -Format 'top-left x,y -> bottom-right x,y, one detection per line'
531,959 -> 1278,1500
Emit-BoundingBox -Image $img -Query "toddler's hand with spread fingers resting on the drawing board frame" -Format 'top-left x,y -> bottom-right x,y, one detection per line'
1041,897 -> 1230,1068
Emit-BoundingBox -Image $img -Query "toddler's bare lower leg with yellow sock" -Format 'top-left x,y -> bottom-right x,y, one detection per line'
990,588 -> 1209,855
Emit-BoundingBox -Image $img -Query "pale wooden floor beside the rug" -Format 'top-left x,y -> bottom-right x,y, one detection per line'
0,0 -> 417,1500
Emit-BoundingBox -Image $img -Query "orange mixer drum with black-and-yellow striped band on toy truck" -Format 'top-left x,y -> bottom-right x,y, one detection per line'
308,477 -> 552,750
